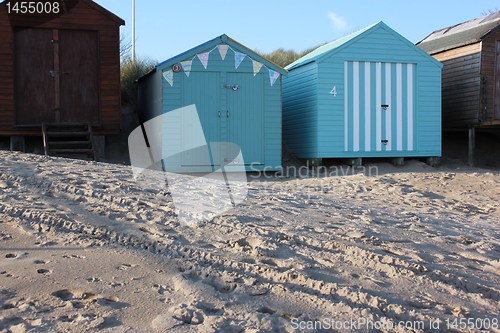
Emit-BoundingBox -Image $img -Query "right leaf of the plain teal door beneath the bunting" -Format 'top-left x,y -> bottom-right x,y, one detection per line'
225,73 -> 265,165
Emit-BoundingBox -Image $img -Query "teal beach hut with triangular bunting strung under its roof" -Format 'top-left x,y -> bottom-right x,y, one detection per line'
138,35 -> 286,172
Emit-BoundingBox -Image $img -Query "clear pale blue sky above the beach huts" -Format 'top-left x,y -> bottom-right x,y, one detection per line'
96,0 -> 500,61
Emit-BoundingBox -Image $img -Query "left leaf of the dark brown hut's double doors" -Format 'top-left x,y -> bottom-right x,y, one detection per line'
14,29 -> 57,126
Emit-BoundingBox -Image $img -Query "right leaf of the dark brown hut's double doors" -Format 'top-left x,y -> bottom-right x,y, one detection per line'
59,30 -> 99,122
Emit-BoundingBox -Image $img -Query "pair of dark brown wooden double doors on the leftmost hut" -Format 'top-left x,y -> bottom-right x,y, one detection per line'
14,29 -> 99,126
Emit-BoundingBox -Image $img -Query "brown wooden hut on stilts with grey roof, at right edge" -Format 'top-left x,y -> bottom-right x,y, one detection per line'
417,11 -> 500,164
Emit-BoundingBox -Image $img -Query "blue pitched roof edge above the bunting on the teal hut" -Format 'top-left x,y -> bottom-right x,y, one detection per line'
154,34 -> 288,75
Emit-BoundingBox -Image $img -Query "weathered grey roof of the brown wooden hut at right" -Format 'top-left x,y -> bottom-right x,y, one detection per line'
417,11 -> 500,54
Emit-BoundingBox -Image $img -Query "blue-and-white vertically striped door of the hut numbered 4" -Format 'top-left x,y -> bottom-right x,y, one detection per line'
344,61 -> 416,153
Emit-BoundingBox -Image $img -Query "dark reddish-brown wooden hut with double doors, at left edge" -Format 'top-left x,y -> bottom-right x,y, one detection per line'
0,0 -> 124,154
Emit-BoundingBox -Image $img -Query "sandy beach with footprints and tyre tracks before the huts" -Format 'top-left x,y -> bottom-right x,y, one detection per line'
0,151 -> 500,332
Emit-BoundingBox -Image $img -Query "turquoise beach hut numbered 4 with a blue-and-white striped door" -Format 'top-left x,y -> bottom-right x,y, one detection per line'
283,22 -> 442,159
